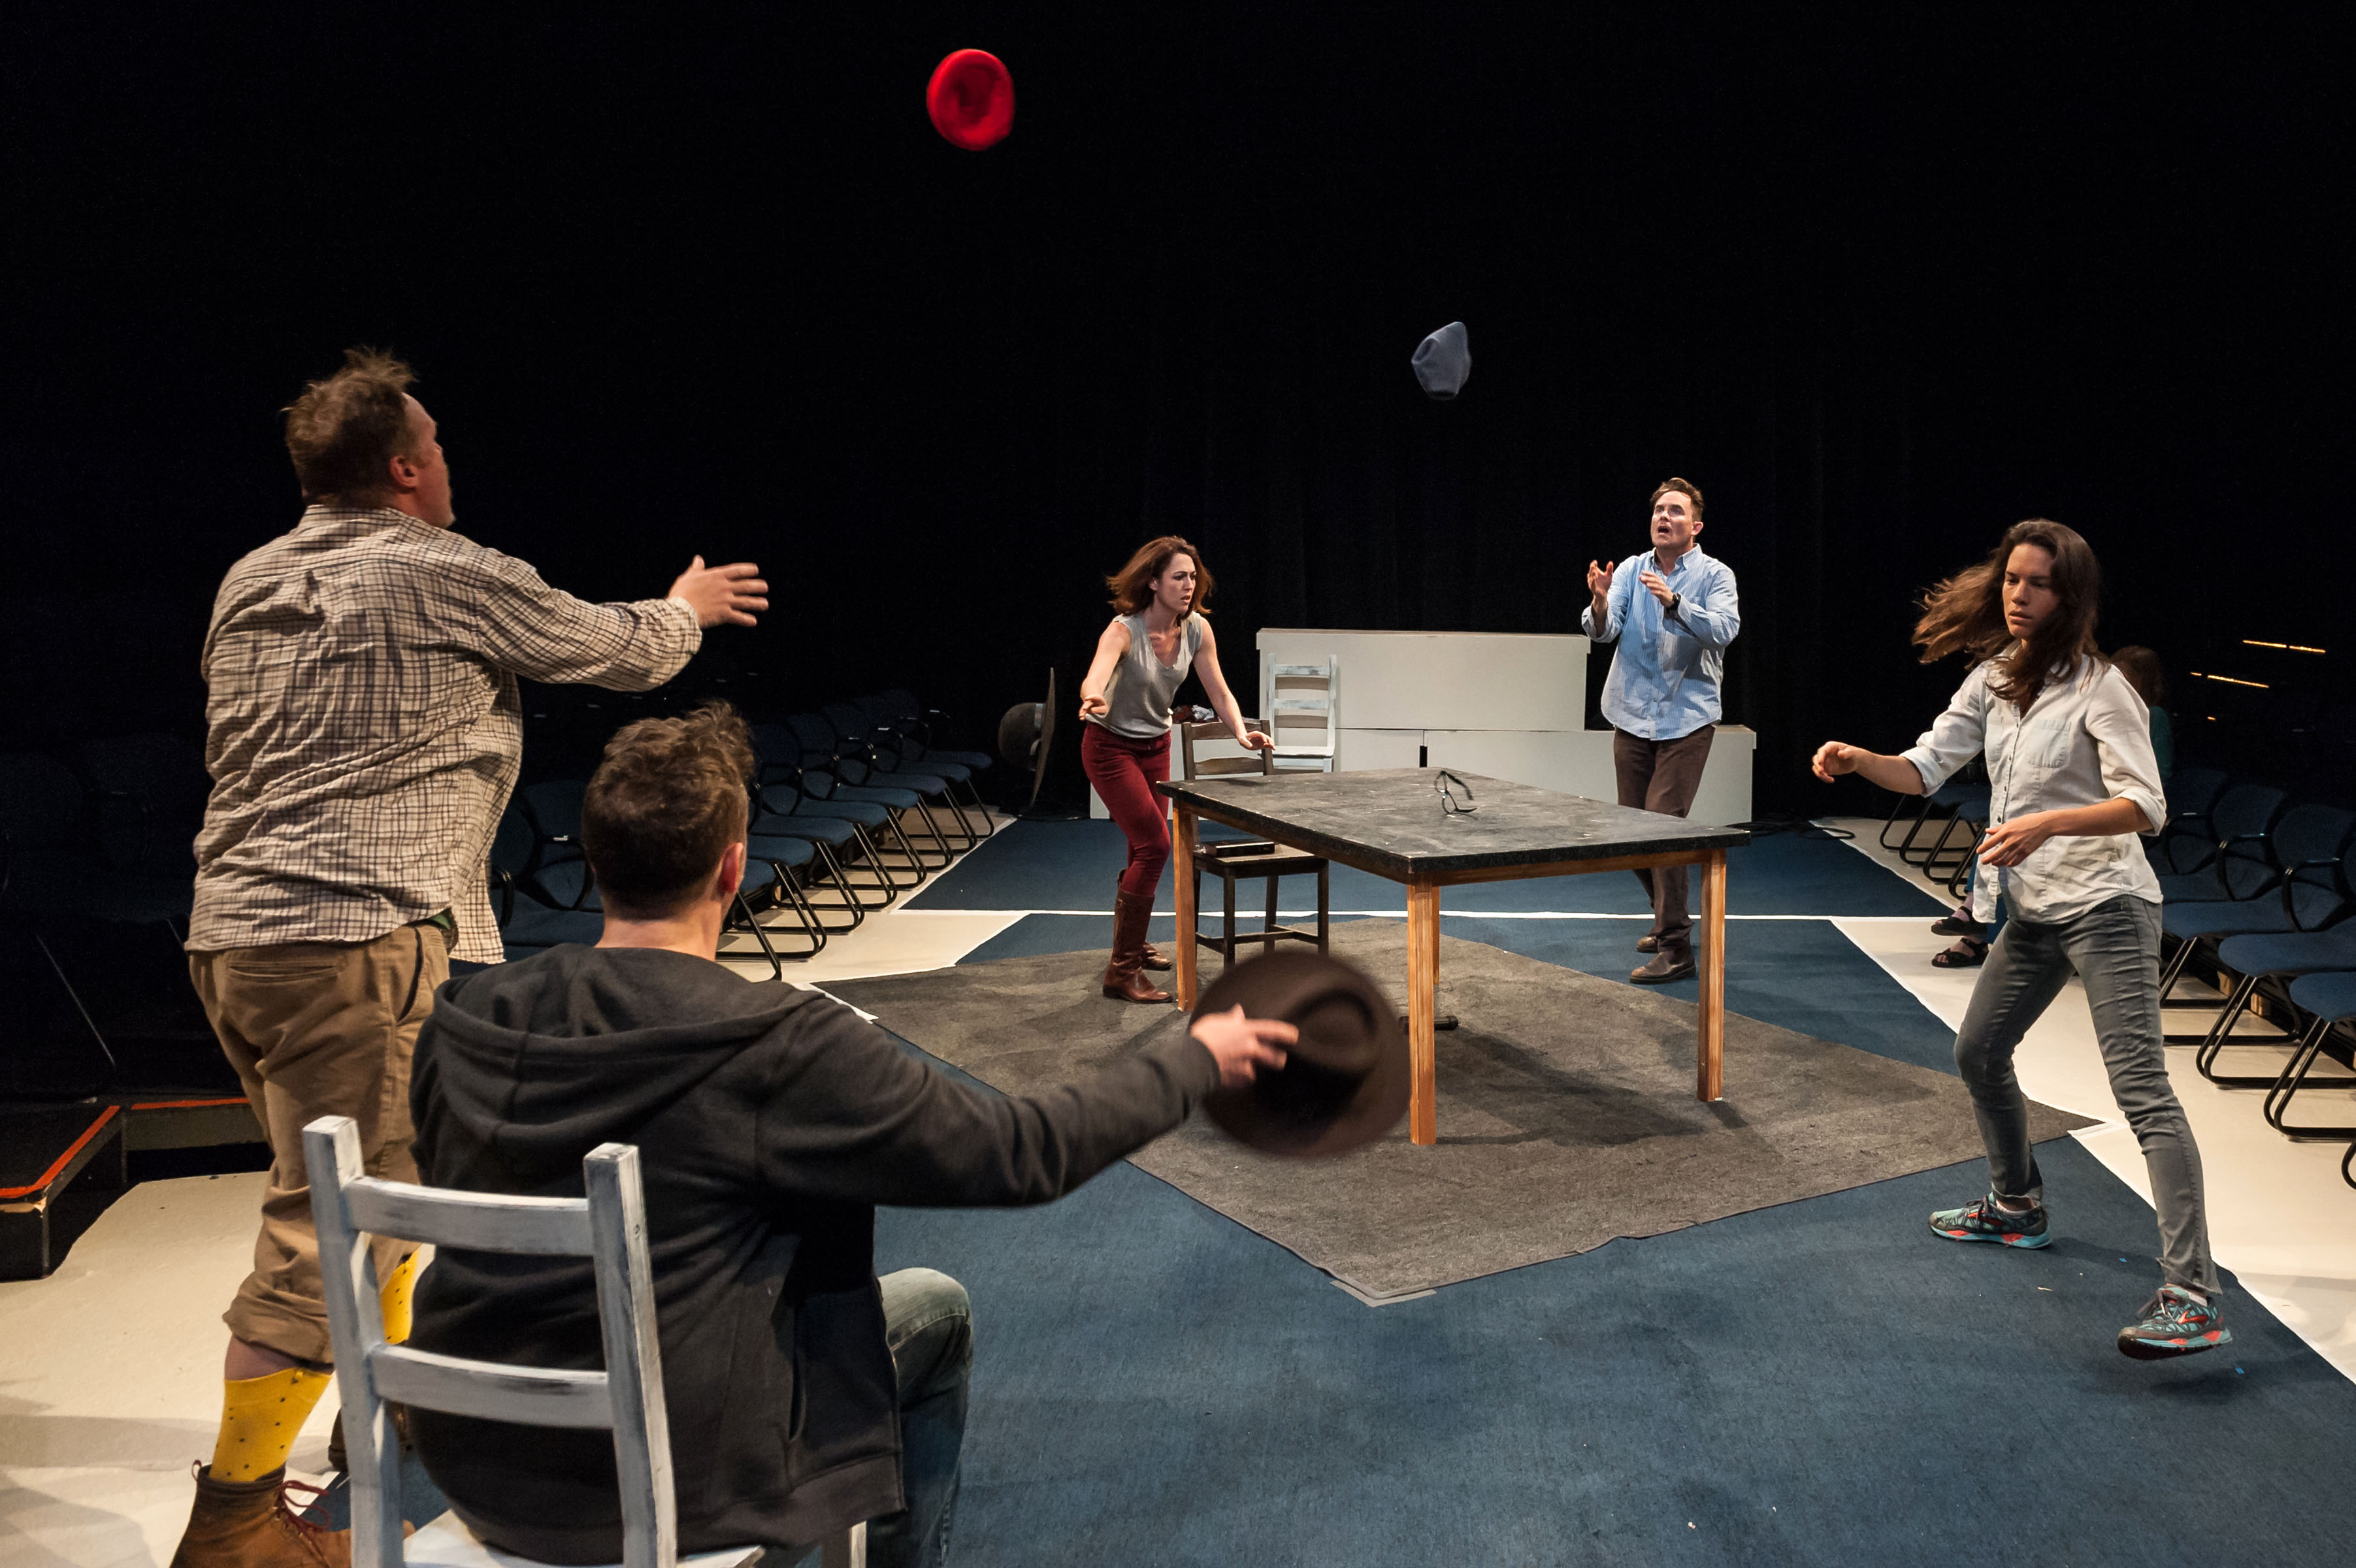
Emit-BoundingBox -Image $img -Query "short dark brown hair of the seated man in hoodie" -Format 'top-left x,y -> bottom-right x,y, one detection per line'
582,702 -> 754,918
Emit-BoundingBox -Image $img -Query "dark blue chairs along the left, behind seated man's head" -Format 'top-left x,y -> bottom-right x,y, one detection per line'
493,692 -> 994,975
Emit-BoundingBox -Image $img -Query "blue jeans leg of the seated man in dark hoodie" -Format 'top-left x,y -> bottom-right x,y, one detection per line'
867,1269 -> 973,1568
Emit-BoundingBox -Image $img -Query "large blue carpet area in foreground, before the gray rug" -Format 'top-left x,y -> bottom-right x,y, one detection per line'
876,1139 -> 2356,1568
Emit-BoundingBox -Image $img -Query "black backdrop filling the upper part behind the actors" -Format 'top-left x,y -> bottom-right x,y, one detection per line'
0,5 -> 2351,810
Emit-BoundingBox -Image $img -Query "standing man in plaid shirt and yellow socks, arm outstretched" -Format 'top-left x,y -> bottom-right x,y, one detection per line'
172,348 -> 768,1568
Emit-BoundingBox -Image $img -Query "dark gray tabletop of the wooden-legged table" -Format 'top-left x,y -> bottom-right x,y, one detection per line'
1154,768 -> 1750,883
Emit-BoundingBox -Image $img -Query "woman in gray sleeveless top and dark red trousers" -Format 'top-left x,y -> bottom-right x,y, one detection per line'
1079,534 -> 1275,1003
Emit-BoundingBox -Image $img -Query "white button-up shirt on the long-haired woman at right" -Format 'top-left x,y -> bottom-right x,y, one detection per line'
1901,659 -> 2168,925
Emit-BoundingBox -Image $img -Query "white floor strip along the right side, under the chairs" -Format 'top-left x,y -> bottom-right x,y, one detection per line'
1833,819 -> 2356,1377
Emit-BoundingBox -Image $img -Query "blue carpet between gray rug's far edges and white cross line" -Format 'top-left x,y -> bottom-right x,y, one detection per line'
961,904 -> 1955,1073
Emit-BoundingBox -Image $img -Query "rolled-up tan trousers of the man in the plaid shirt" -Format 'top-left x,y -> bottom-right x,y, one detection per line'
188,921 -> 450,1365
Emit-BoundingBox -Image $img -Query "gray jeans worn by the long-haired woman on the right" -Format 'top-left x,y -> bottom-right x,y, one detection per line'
1955,894 -> 2217,1295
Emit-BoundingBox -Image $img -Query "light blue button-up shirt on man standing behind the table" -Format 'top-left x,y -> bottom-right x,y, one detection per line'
1579,544 -> 1743,740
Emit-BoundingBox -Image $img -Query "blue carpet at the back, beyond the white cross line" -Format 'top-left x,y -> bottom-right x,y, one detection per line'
909,822 -> 1946,921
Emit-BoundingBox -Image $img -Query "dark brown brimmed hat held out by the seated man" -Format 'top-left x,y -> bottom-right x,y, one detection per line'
1194,951 -> 1407,1156
